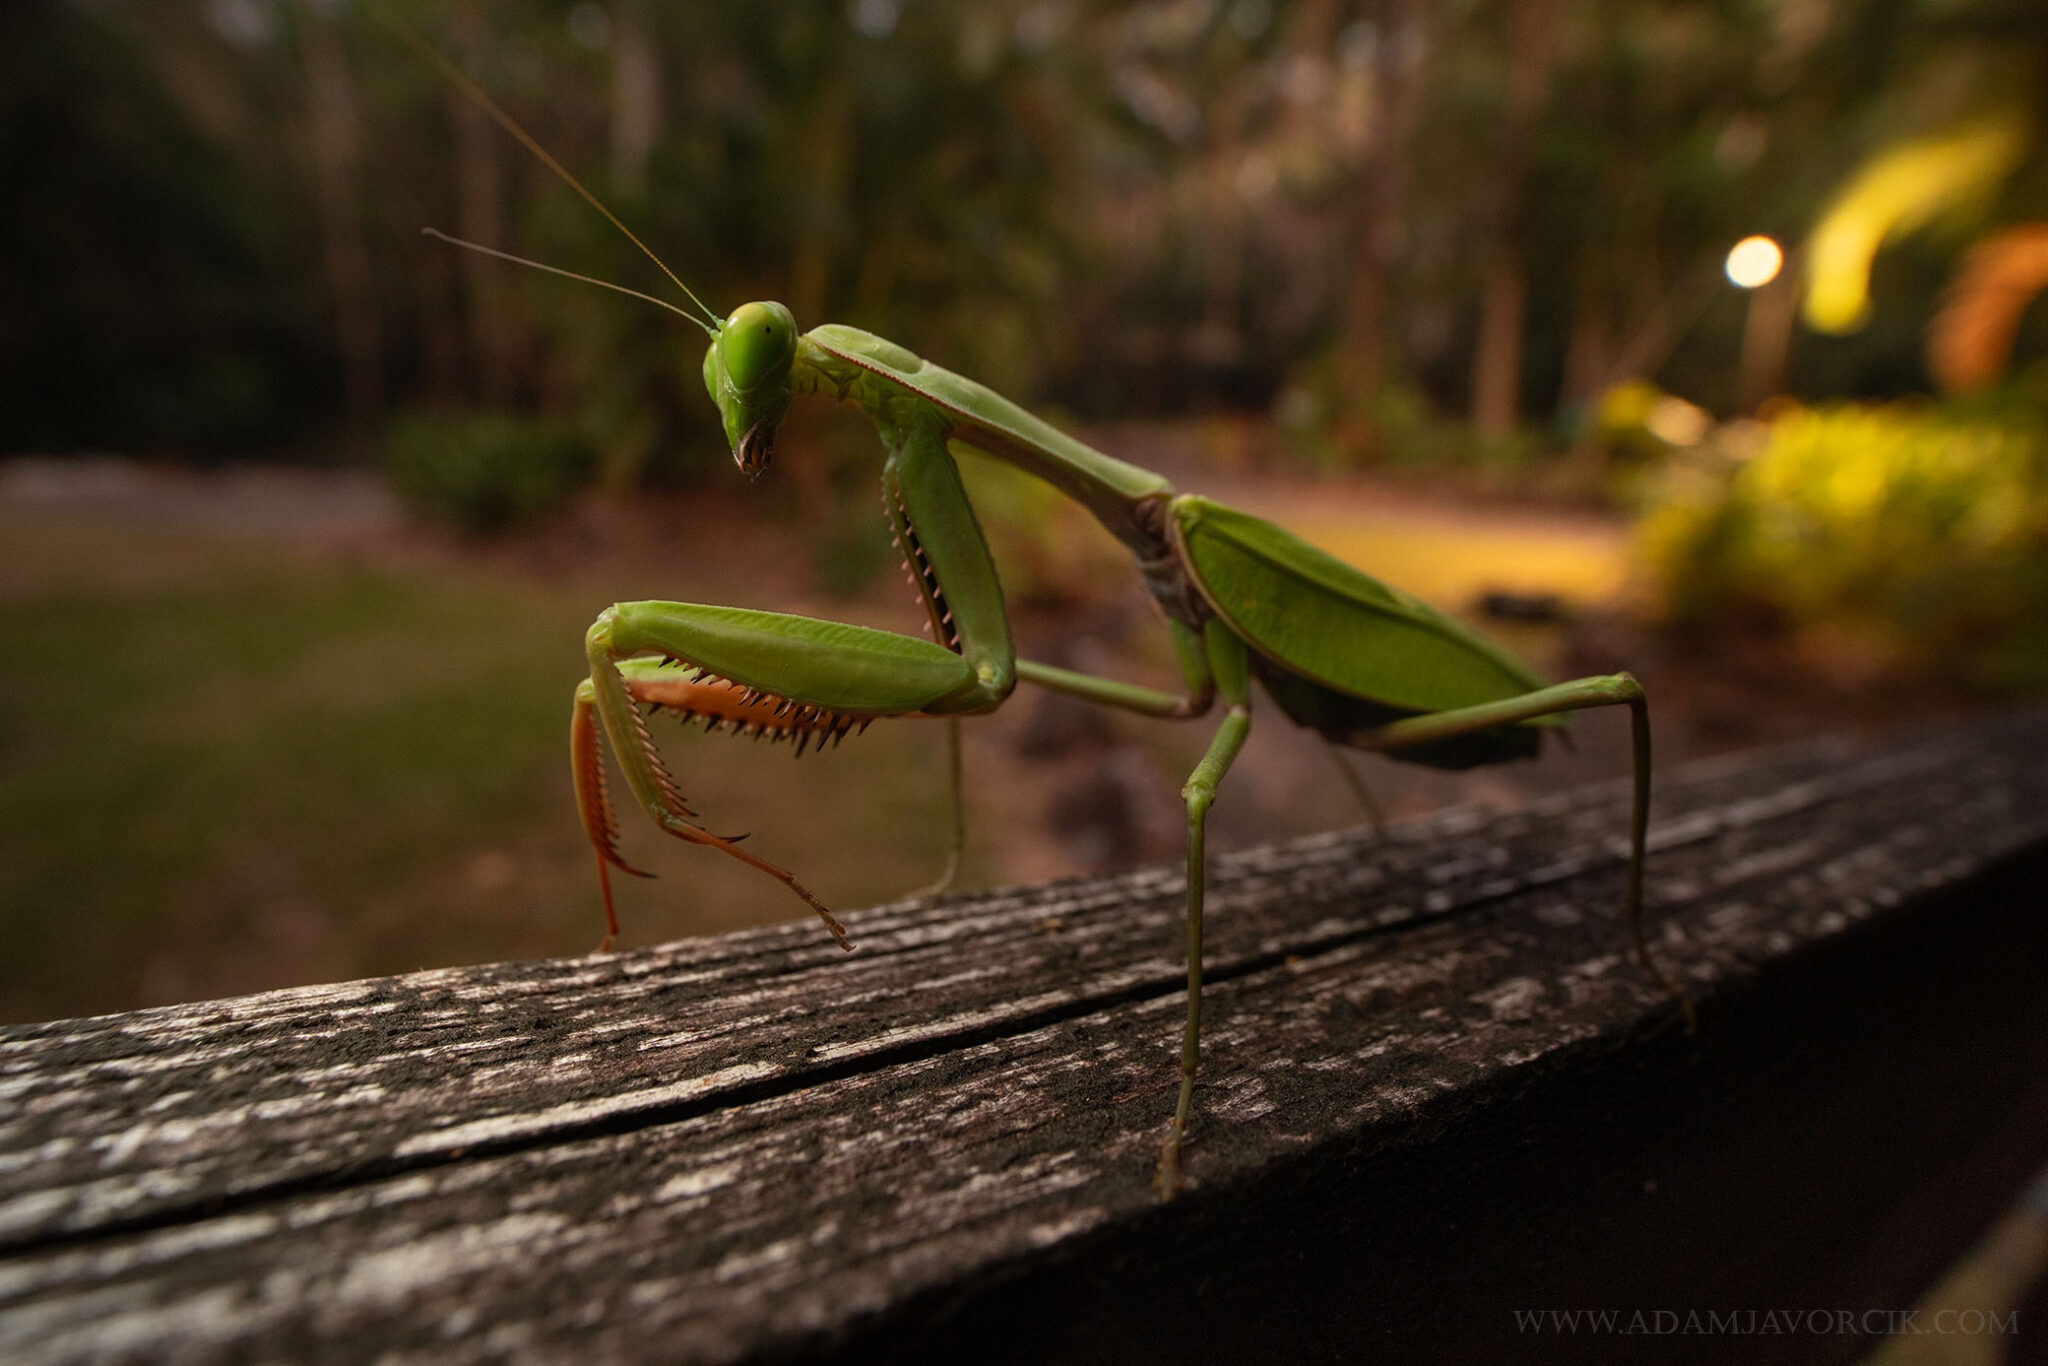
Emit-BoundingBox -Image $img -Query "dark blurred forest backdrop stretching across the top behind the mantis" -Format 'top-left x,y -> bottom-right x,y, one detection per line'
0,0 -> 2048,464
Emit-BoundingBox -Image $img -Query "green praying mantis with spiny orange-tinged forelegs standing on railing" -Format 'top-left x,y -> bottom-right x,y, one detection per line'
408,33 -> 1692,1198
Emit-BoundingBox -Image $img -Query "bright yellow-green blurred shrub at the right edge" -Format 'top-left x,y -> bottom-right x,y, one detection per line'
1638,403 -> 2048,684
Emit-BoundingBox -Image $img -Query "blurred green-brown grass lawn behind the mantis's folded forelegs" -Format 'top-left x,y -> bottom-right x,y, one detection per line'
0,518 -> 940,1020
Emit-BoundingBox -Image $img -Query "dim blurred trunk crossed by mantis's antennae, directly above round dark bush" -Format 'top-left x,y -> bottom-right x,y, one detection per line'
446,0 -> 522,403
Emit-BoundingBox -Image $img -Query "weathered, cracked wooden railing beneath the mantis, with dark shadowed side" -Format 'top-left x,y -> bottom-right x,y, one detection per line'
0,715 -> 2048,1362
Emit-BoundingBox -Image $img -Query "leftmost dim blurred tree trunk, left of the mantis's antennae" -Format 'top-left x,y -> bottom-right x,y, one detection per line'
295,0 -> 383,428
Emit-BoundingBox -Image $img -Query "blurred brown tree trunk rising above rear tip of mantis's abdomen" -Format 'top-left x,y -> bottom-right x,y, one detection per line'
1473,0 -> 1556,436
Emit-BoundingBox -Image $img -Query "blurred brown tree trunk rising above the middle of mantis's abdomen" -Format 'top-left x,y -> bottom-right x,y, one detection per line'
1337,0 -> 1427,405
